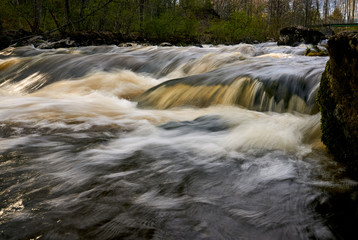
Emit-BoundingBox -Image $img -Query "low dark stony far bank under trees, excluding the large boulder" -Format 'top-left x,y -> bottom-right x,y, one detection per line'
0,29 -> 268,49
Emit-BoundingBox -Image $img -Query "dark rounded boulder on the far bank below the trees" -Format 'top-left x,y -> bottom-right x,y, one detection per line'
277,26 -> 326,46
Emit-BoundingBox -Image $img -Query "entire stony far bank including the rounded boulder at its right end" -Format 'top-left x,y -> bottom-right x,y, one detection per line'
0,26 -> 326,49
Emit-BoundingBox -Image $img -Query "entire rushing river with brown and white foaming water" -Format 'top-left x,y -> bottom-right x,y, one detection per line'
0,43 -> 358,240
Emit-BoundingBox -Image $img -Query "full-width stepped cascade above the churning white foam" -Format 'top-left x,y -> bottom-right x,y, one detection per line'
0,44 -> 327,114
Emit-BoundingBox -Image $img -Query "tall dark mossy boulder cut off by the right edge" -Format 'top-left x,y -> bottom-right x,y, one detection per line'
317,32 -> 358,172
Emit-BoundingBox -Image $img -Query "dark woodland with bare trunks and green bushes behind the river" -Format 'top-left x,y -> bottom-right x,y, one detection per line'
0,0 -> 356,43
